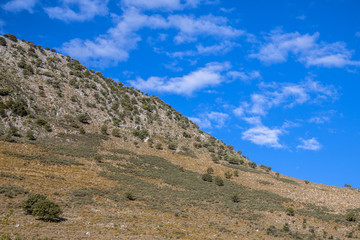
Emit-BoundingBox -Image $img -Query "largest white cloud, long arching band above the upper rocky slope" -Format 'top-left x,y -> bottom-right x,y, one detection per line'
62,8 -> 243,66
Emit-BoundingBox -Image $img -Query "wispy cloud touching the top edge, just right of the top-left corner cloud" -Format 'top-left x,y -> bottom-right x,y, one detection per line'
44,0 -> 108,22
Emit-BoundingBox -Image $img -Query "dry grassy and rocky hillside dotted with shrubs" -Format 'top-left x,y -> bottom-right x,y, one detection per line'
0,35 -> 360,239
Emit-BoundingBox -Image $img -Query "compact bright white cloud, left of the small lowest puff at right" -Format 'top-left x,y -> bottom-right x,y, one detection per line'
242,126 -> 284,148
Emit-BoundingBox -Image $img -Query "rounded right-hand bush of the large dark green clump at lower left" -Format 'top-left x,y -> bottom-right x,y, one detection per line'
32,199 -> 61,221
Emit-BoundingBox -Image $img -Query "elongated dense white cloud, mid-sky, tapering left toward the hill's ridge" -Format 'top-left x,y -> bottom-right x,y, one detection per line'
129,62 -> 231,95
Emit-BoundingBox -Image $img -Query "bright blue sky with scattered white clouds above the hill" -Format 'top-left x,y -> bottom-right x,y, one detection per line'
0,0 -> 360,187
